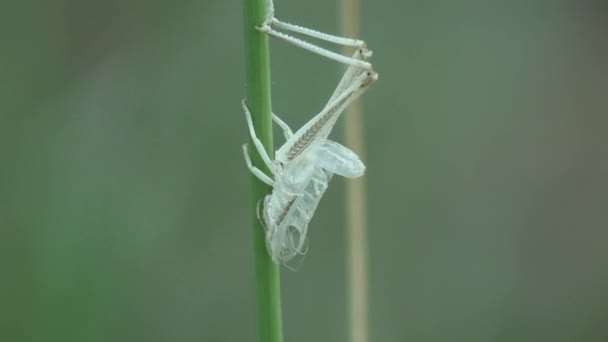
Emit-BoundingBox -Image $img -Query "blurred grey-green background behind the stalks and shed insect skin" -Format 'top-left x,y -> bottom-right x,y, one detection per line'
0,0 -> 608,342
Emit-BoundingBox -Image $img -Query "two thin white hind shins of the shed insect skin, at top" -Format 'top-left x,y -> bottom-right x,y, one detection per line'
256,0 -> 372,70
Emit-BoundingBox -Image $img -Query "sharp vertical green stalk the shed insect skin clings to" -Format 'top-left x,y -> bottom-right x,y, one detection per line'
243,0 -> 283,342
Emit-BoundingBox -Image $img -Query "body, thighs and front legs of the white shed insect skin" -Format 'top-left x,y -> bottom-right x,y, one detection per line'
243,48 -> 378,263
